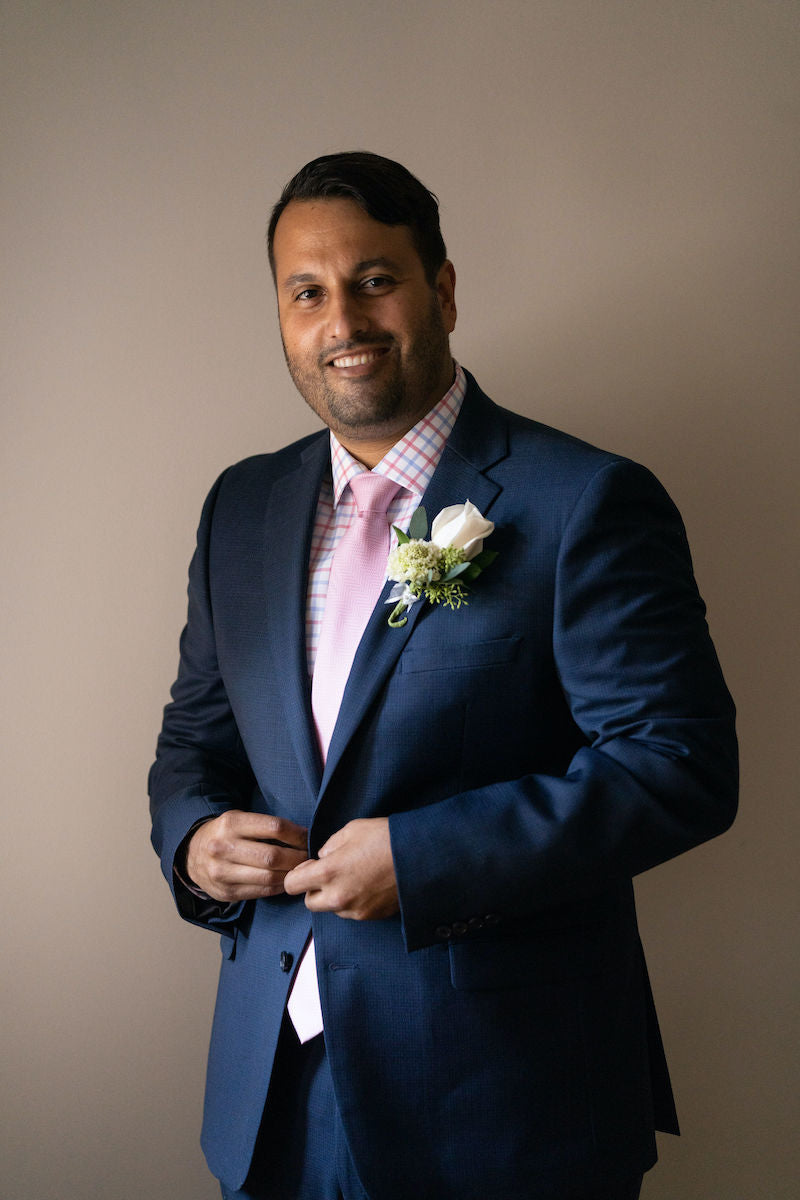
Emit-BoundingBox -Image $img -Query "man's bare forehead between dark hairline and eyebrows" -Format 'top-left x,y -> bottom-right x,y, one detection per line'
272,196 -> 422,287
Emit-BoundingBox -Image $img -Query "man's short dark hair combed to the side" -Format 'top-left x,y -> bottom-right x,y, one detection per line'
266,150 -> 447,286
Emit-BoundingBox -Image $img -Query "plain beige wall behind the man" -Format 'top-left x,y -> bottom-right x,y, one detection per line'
0,0 -> 800,1200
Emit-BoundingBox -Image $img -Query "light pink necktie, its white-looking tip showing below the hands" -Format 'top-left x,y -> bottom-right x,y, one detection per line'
287,472 -> 401,1042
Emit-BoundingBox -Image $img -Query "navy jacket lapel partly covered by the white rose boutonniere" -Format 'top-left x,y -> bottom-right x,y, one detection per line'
320,374 -> 507,797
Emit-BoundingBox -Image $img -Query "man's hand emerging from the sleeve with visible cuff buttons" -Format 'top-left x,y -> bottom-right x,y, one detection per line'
284,817 -> 399,920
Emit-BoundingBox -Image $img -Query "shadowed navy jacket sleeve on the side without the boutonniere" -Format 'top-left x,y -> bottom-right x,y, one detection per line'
149,475 -> 254,930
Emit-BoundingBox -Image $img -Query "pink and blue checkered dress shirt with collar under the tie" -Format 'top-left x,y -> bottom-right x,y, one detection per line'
306,364 -> 467,676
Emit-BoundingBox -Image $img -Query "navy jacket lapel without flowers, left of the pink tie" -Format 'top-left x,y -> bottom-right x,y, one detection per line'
264,434 -> 330,818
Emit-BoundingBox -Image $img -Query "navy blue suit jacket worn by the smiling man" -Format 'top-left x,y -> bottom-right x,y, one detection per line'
150,369 -> 736,1200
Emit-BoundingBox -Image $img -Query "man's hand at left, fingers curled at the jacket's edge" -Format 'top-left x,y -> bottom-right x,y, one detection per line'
186,809 -> 308,904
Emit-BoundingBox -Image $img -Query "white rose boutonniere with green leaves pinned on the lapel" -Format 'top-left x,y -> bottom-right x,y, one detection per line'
386,500 -> 498,629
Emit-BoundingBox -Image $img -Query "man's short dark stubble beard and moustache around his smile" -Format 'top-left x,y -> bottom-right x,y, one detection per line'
282,293 -> 452,437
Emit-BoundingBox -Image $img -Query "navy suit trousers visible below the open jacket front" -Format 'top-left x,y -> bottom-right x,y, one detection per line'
222,1015 -> 642,1200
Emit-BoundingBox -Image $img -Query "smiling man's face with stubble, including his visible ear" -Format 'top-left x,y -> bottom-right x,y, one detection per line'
273,197 -> 456,445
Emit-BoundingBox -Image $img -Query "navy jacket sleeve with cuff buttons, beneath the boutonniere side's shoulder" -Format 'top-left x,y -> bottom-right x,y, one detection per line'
390,461 -> 738,950
